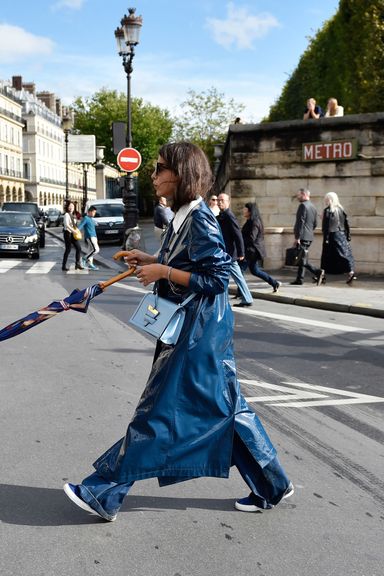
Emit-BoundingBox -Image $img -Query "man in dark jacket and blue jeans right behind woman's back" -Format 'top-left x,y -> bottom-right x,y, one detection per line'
217,192 -> 253,307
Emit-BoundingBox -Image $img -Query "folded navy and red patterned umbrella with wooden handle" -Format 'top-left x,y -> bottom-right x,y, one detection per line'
0,252 -> 136,342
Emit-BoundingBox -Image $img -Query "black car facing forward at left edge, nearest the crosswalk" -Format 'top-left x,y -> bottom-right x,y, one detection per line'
0,211 -> 40,260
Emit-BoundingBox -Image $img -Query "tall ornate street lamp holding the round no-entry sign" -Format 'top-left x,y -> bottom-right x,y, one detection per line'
115,8 -> 143,248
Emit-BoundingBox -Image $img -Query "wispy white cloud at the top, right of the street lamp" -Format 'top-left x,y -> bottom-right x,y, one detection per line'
207,2 -> 280,49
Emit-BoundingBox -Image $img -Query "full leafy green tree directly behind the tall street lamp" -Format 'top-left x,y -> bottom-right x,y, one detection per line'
72,88 -> 173,209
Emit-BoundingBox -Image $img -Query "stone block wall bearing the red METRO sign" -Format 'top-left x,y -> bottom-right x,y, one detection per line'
216,113 -> 384,274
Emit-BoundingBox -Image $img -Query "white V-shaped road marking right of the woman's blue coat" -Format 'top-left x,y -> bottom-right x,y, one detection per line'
239,379 -> 384,408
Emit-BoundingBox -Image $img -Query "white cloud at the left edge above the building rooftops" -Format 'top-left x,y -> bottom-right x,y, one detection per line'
0,24 -> 54,65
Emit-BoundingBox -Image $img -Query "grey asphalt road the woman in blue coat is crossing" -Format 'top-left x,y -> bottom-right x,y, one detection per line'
0,238 -> 384,576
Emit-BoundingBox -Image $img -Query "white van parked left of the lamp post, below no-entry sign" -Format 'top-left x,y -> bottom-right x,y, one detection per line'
86,198 -> 124,243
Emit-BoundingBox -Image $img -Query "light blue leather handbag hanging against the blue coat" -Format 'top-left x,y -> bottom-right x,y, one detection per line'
129,292 -> 196,345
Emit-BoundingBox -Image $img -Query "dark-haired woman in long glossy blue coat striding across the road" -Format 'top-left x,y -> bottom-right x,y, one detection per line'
64,142 -> 293,521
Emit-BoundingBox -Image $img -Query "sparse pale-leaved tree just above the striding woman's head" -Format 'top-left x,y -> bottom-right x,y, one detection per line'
173,87 -> 244,162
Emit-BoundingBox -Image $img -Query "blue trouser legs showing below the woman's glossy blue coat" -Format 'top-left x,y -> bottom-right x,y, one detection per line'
75,432 -> 289,520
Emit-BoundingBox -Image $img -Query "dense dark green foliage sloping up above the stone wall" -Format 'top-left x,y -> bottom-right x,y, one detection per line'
267,0 -> 384,121
